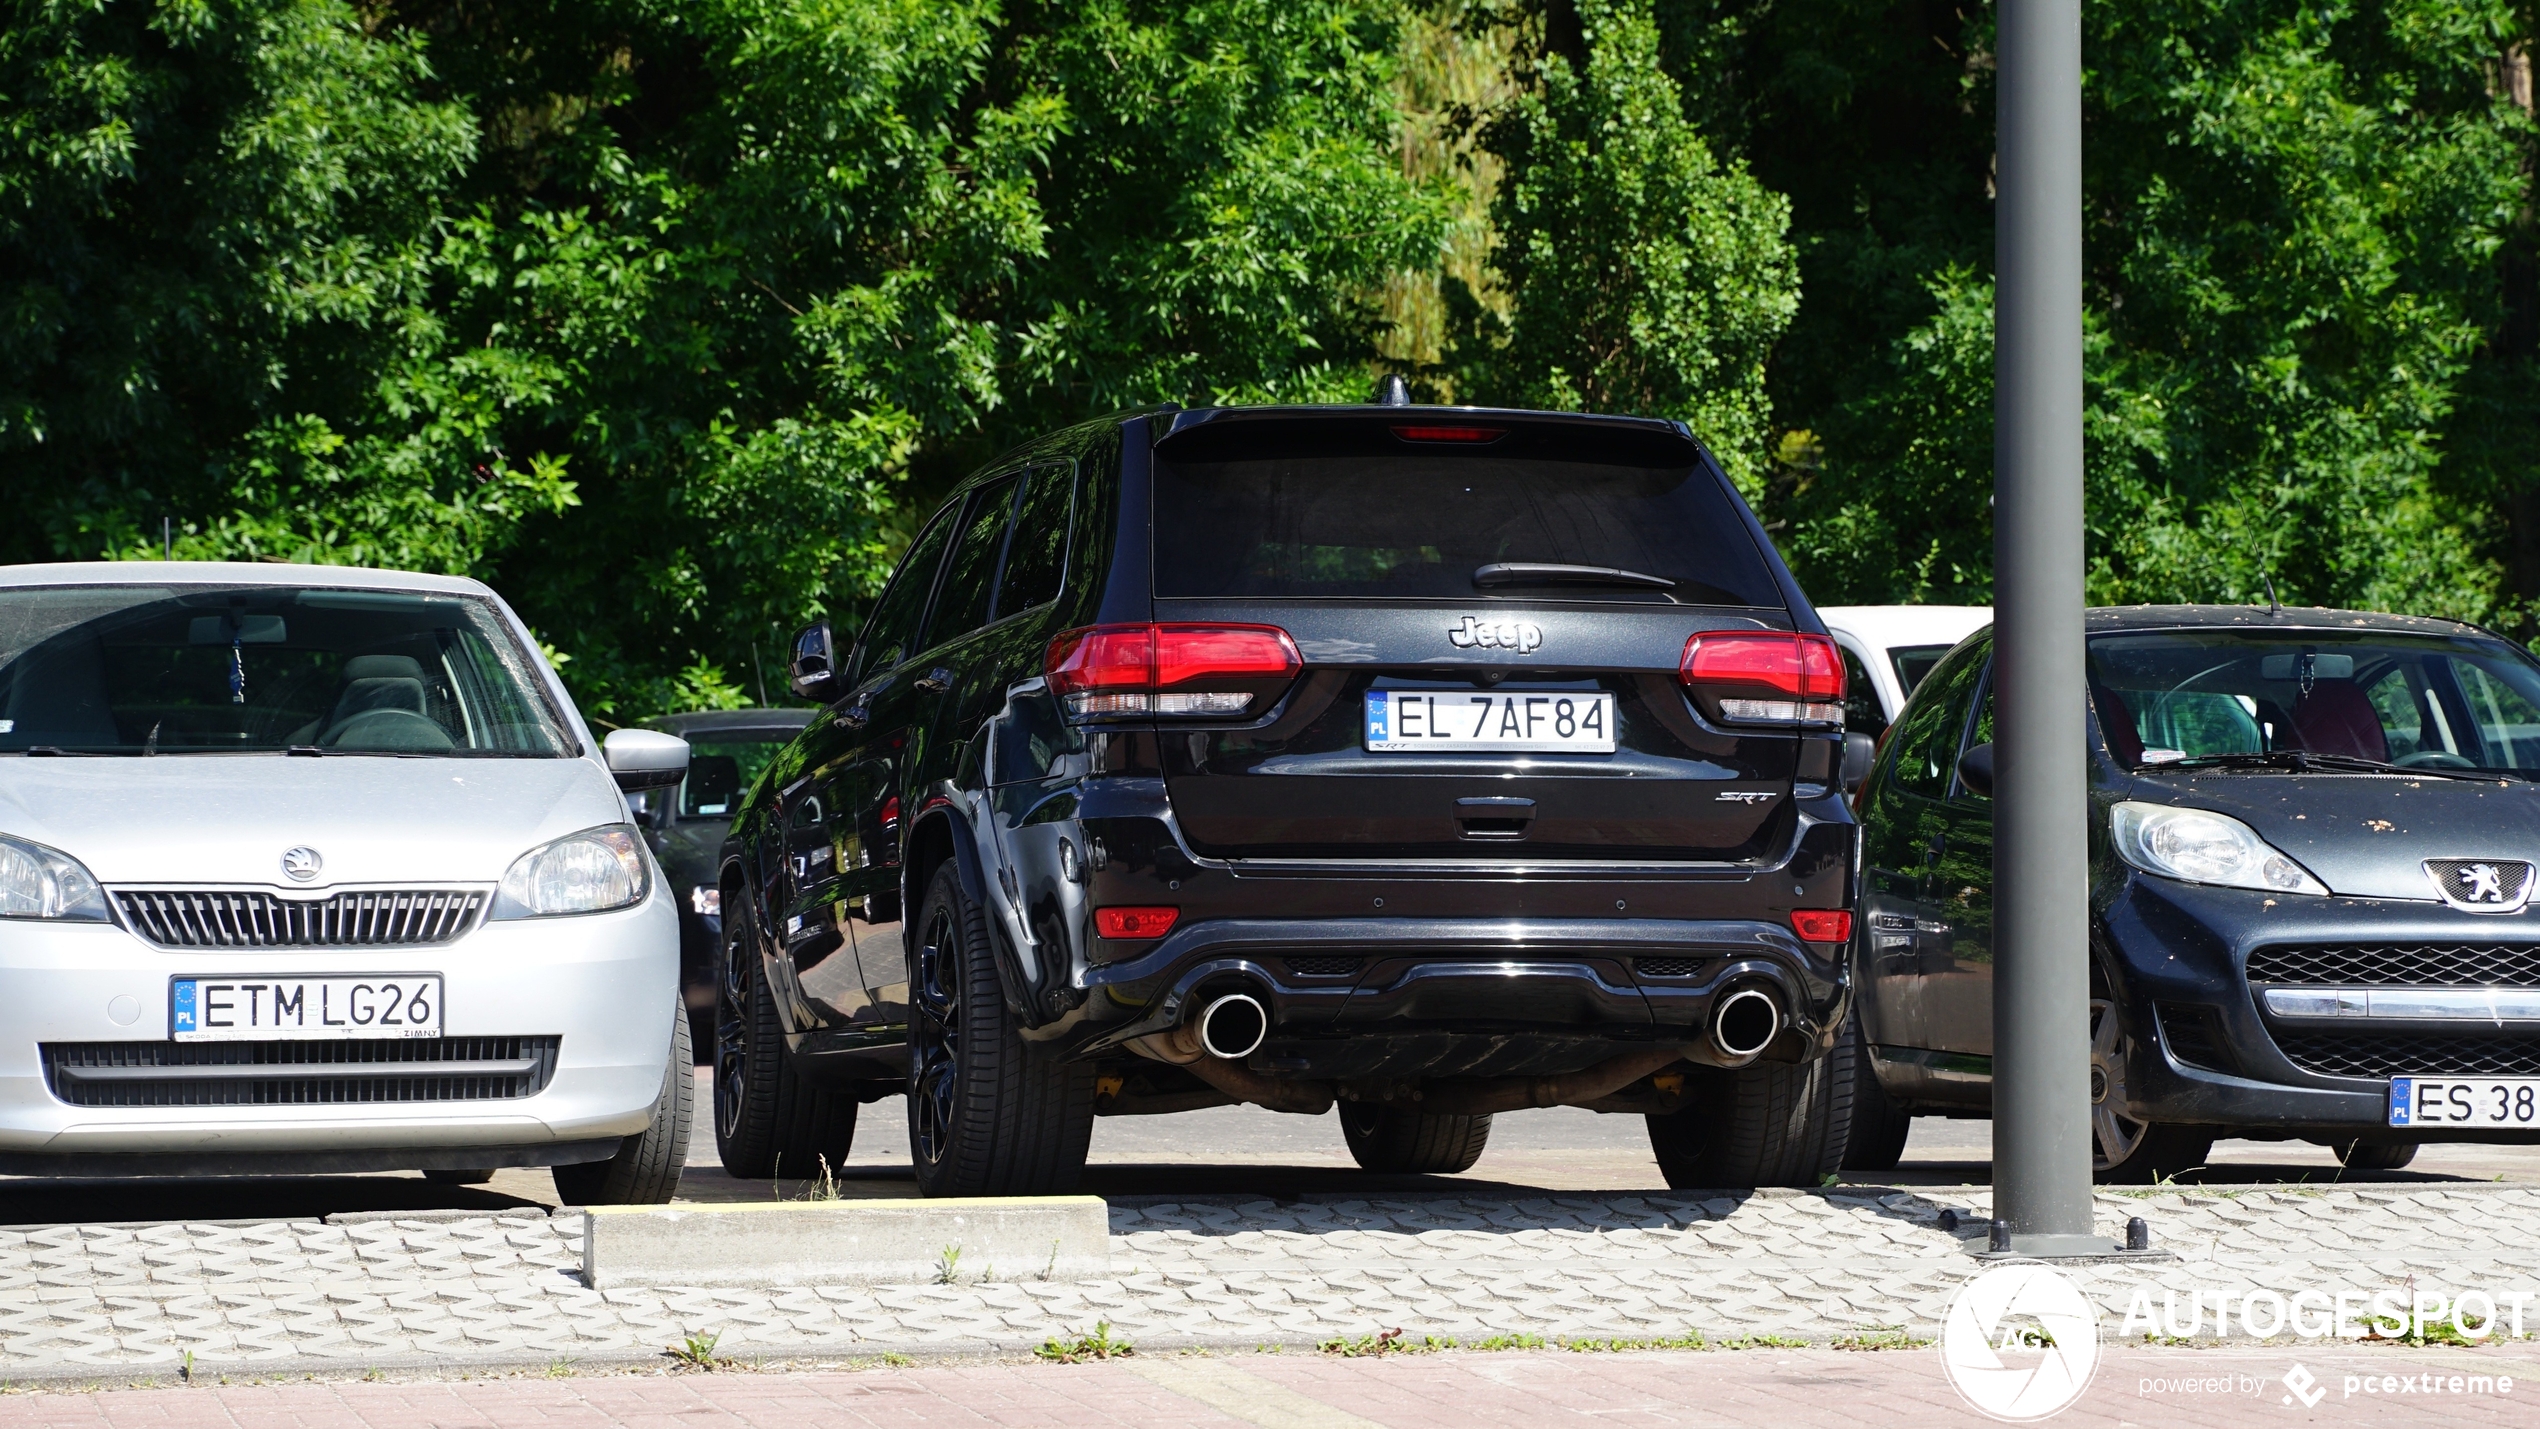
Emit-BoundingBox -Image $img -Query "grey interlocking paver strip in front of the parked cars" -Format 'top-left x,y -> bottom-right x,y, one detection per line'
0,1185 -> 2540,1378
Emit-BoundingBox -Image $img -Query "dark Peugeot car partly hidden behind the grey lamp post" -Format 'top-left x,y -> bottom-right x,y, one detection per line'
1847,607 -> 2540,1180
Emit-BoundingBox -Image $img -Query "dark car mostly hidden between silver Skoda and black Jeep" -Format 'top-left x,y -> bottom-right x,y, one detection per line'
627,708 -> 810,1058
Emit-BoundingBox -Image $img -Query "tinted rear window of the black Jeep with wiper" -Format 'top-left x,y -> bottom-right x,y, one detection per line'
1156,452 -> 1783,609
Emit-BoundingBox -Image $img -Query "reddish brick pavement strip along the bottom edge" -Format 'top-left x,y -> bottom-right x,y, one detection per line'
0,1348 -> 2540,1429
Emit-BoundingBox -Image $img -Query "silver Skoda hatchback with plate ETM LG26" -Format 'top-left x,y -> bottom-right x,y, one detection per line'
0,563 -> 691,1203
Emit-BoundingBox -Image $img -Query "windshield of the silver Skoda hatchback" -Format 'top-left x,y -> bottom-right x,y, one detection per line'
0,584 -> 572,759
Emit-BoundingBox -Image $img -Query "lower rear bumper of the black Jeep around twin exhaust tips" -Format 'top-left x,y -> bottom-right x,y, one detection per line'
1067,916 -> 1847,1076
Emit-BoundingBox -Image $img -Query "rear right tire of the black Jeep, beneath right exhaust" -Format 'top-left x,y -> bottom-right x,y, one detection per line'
1648,1038 -> 1859,1190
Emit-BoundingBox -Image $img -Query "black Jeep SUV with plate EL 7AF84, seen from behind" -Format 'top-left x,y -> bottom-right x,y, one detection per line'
714,404 -> 1857,1195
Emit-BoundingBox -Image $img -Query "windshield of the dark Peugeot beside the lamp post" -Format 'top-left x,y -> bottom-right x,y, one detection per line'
2090,629 -> 2540,774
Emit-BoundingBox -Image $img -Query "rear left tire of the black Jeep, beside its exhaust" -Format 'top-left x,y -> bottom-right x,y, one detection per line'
909,863 -> 1095,1195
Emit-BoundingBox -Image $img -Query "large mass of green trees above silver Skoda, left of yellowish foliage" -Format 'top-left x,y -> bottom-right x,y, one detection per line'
0,0 -> 1445,718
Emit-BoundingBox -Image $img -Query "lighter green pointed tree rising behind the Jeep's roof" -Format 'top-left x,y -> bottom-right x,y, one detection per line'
1455,0 -> 1798,497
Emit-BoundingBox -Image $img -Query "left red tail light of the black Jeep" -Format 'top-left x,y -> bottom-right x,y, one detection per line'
1046,622 -> 1306,716
